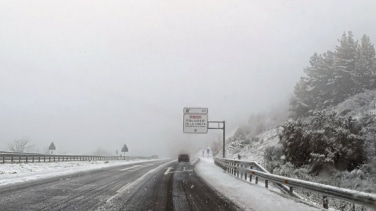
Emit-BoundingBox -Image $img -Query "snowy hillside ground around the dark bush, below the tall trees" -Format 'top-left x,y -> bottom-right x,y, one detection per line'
226,91 -> 376,193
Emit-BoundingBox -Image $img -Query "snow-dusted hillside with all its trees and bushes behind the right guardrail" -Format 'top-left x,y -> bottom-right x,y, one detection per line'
214,32 -> 376,208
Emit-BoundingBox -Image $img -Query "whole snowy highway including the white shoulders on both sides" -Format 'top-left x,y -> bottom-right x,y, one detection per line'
0,158 -> 324,210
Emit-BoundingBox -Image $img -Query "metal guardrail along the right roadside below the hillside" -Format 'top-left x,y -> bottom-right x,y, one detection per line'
214,158 -> 376,210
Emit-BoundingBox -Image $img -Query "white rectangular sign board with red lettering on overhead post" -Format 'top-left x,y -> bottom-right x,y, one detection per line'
183,108 -> 208,133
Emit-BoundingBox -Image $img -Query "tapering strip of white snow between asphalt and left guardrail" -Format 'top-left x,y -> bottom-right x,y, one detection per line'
0,160 -> 157,186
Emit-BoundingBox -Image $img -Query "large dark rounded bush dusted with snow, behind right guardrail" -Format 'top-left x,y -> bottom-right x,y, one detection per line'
280,112 -> 366,170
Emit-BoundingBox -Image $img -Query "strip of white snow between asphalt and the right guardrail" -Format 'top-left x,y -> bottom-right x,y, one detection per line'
195,158 -> 321,211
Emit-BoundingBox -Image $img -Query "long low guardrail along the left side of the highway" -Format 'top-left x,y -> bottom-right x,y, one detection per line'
0,152 -> 152,164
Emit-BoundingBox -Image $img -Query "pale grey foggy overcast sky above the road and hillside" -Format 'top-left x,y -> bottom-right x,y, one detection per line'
0,0 -> 376,156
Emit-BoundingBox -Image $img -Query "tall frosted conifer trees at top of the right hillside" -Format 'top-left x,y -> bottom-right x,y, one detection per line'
290,32 -> 376,118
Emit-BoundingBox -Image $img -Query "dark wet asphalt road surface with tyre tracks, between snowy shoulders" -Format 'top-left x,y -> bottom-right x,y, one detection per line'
0,160 -> 239,211
